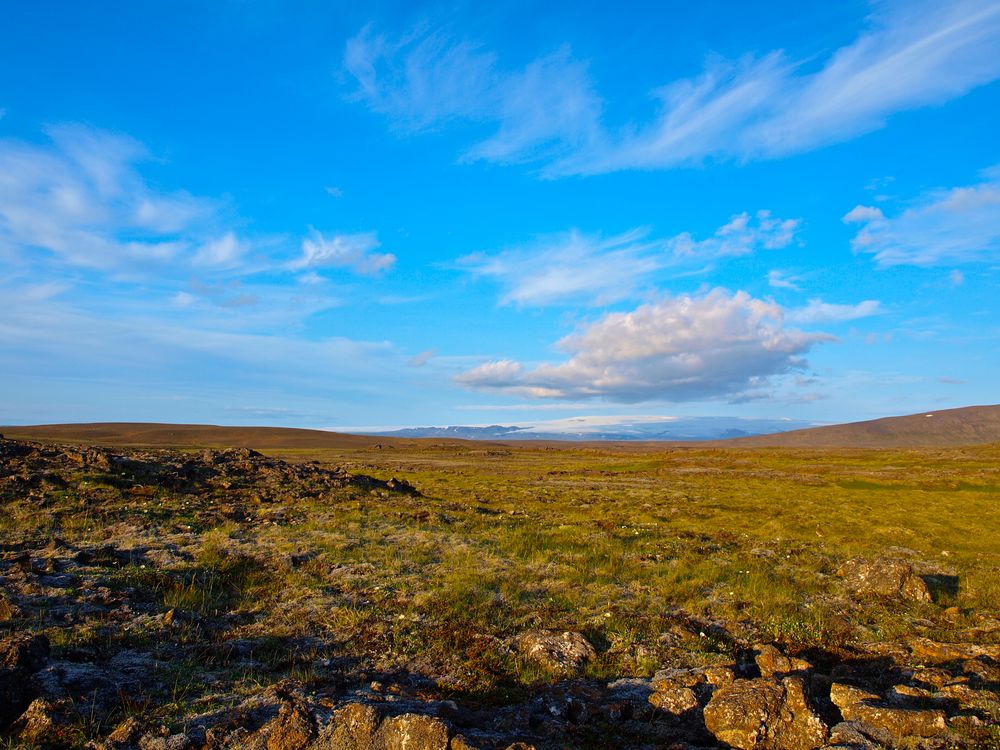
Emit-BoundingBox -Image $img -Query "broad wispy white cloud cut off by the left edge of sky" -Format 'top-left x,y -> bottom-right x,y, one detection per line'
0,125 -> 225,272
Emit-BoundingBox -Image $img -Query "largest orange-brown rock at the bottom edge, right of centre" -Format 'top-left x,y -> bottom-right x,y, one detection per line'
705,677 -> 828,750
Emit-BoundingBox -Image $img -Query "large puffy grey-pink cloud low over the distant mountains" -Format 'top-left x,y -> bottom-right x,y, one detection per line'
456,289 -> 832,402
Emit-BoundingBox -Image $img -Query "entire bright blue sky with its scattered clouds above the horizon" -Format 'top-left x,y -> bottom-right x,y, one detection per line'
0,0 -> 1000,428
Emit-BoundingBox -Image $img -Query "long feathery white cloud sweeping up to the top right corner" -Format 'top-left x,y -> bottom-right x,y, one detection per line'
344,0 -> 1000,176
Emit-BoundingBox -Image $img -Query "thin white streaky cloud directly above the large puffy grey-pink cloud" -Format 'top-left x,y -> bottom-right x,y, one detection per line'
458,211 -> 800,306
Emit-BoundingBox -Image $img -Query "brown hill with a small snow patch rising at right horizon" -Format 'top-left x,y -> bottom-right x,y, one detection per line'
714,405 -> 1000,448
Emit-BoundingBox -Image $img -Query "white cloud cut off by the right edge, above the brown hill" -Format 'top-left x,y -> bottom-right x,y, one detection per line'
845,169 -> 1000,268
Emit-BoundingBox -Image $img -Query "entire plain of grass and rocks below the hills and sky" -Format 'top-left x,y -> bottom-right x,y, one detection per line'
0,428 -> 1000,750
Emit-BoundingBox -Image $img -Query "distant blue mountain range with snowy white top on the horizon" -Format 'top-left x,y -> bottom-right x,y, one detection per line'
363,416 -> 815,442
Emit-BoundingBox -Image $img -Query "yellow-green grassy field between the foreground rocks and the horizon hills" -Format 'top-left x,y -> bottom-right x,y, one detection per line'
0,441 -> 1000,748
